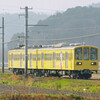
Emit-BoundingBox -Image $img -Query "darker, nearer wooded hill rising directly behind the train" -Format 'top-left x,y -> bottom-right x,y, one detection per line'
9,7 -> 100,59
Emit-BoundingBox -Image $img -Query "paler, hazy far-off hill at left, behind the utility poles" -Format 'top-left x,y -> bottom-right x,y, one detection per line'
0,12 -> 49,41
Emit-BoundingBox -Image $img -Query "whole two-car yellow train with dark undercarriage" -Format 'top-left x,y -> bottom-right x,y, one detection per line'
8,45 -> 99,79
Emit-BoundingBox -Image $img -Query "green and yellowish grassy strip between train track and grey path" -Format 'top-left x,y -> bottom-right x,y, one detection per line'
0,74 -> 100,93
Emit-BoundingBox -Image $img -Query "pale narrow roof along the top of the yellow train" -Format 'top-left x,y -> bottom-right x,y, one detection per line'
9,45 -> 97,51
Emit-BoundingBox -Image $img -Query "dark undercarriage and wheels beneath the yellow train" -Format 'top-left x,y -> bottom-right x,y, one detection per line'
10,68 -> 93,79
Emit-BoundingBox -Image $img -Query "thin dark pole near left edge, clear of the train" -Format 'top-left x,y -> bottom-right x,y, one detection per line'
2,17 -> 4,73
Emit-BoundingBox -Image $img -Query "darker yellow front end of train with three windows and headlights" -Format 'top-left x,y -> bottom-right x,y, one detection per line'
74,46 -> 99,78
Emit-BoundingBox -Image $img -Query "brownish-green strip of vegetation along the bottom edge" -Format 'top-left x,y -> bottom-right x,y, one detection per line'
0,94 -> 91,100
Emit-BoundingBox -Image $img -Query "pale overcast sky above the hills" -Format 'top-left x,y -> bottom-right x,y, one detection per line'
0,0 -> 100,14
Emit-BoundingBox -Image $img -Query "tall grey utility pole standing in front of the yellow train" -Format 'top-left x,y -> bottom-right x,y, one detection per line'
25,7 -> 28,78
